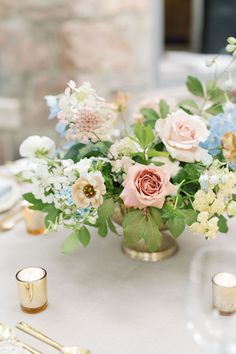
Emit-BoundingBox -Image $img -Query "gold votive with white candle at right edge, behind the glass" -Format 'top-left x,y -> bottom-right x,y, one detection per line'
212,273 -> 236,315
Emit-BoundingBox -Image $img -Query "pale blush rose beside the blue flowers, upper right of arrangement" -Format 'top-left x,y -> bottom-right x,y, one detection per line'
155,110 -> 209,162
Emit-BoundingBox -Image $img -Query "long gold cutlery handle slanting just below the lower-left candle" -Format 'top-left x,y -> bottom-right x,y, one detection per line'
16,322 -> 92,354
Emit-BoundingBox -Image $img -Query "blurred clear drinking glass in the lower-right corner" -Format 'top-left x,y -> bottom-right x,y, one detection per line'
187,246 -> 236,354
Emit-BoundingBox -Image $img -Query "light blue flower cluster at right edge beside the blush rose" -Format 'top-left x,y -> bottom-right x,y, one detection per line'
201,104 -> 236,156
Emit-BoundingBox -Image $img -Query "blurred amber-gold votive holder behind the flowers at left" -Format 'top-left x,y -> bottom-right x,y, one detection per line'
23,205 -> 46,235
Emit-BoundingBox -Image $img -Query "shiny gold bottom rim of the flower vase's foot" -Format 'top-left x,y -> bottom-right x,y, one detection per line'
122,240 -> 179,262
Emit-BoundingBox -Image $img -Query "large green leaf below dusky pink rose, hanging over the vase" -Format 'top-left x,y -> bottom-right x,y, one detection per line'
123,208 -> 162,252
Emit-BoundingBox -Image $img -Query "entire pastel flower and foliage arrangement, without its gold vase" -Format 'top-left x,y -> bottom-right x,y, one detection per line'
20,37 -> 236,253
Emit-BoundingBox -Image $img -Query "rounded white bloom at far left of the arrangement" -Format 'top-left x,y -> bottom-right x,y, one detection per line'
20,135 -> 56,158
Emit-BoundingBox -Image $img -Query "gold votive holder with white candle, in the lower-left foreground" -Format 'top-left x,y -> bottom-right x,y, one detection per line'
16,267 -> 48,314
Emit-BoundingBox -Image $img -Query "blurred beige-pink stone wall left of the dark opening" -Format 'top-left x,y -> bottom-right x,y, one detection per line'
0,0 -> 155,160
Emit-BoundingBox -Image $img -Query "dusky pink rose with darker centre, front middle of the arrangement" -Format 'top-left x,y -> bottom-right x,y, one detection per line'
120,164 -> 176,209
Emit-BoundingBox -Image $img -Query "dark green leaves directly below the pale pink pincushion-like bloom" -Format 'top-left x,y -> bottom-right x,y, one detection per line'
64,141 -> 112,162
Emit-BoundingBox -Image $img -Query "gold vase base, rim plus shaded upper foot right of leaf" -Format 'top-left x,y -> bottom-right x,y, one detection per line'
122,233 -> 178,262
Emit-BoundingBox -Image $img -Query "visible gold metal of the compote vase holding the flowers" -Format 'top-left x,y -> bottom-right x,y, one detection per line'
113,204 -> 178,262
